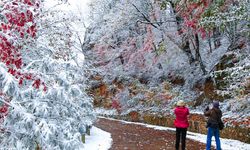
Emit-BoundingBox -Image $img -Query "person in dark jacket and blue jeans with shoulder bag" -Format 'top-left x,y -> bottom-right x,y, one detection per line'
204,101 -> 222,150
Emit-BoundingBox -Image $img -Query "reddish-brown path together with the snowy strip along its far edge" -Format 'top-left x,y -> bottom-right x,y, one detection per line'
95,117 -> 250,150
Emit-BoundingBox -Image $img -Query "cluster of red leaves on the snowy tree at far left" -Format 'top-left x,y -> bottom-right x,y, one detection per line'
0,0 -> 46,91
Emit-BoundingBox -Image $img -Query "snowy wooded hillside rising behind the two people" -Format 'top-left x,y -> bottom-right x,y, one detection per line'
83,0 -> 250,141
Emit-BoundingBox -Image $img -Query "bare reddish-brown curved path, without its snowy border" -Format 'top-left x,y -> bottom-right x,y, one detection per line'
95,118 -> 213,150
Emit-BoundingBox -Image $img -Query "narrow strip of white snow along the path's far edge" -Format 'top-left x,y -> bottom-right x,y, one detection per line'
99,117 -> 250,150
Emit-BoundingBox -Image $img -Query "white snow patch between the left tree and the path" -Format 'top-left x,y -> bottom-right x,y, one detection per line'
84,127 -> 112,150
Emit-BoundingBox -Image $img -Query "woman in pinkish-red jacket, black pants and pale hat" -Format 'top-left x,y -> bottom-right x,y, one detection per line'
174,100 -> 189,150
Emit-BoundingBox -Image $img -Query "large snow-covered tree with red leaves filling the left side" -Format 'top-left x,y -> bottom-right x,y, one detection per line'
0,0 -> 95,149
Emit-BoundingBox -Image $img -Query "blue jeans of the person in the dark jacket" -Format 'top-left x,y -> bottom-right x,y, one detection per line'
206,127 -> 221,150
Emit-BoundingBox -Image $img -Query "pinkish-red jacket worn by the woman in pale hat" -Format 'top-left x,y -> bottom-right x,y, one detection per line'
174,106 -> 189,128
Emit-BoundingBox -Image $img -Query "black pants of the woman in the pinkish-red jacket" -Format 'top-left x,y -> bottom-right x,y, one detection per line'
175,128 -> 187,150
